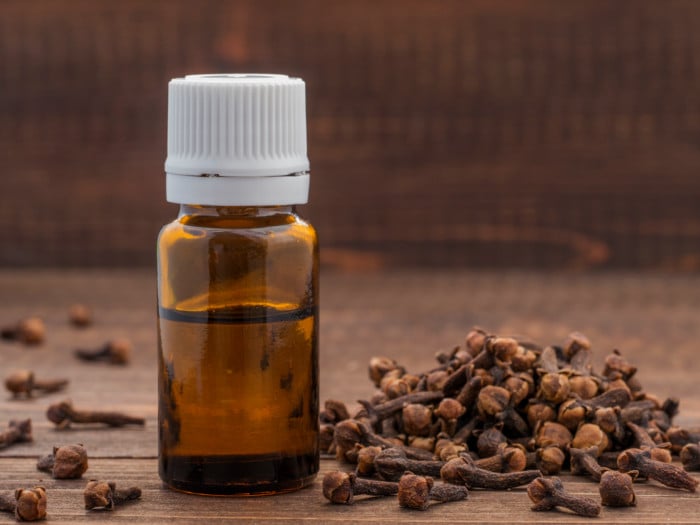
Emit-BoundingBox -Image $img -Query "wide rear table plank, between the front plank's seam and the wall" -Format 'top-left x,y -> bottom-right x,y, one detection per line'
0,271 -> 700,457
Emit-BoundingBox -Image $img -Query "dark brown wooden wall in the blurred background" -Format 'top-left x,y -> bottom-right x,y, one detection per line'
0,0 -> 700,271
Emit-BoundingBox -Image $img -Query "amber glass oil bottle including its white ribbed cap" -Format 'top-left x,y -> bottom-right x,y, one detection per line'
158,75 -> 319,495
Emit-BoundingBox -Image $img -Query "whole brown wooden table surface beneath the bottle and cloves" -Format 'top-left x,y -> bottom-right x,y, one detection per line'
0,270 -> 700,523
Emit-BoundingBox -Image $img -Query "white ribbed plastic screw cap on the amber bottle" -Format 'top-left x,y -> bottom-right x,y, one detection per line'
165,74 -> 309,206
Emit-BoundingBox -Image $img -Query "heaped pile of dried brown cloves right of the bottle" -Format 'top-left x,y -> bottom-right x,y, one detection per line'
320,328 -> 700,516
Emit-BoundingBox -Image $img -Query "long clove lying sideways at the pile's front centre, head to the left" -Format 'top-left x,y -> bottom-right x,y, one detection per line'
440,456 -> 540,490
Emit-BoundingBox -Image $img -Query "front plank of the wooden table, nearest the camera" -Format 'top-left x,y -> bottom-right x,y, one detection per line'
0,458 -> 700,523
